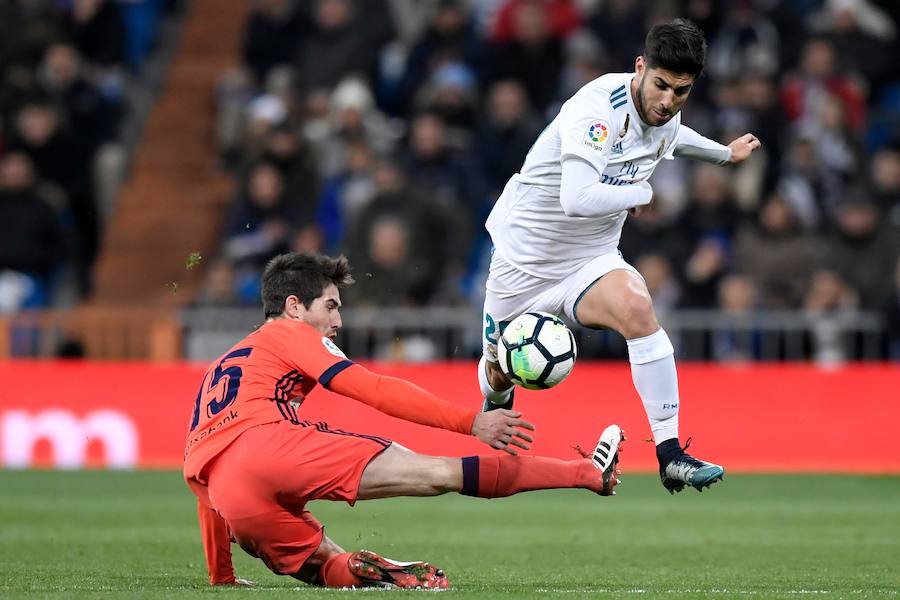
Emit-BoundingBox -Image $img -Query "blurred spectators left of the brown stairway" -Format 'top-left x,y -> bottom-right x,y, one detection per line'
0,0 -> 176,314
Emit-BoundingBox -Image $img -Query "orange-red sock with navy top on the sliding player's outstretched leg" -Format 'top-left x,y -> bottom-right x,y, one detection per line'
460,456 -> 603,498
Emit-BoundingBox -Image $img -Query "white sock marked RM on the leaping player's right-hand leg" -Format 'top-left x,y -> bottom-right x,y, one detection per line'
627,328 -> 678,445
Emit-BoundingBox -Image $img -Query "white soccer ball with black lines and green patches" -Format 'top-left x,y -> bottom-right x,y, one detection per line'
497,312 -> 578,390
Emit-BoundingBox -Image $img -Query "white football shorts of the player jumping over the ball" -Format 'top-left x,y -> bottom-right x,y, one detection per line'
482,252 -> 643,362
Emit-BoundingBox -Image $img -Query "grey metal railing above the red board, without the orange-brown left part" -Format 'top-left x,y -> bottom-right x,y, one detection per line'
181,307 -> 887,363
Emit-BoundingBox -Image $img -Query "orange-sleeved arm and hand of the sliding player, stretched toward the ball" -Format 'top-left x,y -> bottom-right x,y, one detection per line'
327,364 -> 534,454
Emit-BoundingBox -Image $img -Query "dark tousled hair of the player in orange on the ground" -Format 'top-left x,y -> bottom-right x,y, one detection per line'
262,252 -> 353,319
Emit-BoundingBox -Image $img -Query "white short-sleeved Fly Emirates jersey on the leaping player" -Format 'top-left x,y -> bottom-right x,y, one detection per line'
486,73 -> 681,279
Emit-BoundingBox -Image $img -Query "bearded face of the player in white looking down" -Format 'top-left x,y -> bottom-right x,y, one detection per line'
631,56 -> 696,127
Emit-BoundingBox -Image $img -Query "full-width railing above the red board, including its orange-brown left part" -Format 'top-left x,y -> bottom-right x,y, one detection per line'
0,307 -> 888,364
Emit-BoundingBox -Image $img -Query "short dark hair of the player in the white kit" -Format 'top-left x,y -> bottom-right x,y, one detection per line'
644,19 -> 706,77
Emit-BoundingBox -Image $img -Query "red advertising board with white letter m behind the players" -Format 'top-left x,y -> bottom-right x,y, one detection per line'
0,362 -> 900,473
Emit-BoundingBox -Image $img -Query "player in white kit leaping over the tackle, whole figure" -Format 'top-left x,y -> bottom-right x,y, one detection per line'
478,19 -> 759,493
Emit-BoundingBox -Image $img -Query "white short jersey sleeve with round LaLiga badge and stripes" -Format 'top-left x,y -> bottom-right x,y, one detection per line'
559,96 -> 618,173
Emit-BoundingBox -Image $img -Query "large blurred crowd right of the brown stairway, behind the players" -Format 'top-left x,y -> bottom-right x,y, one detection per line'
199,0 -> 900,342
